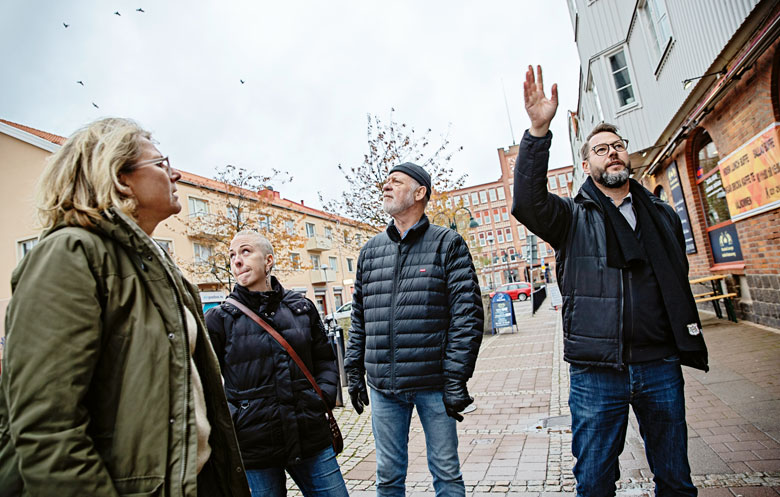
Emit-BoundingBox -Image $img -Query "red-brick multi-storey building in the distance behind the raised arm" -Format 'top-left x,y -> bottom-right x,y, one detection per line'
444,145 -> 573,289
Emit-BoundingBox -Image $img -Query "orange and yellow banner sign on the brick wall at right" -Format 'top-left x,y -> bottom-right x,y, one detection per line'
713,123 -> 780,221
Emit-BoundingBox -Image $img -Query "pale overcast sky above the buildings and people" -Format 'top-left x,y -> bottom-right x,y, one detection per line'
0,0 -> 579,206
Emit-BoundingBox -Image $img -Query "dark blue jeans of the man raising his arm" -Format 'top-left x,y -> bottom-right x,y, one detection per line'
569,355 -> 696,497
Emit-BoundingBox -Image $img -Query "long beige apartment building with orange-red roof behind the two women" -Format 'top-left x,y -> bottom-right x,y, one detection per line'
0,120 -> 375,320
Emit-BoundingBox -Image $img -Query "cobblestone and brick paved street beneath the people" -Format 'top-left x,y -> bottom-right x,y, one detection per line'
288,284 -> 780,497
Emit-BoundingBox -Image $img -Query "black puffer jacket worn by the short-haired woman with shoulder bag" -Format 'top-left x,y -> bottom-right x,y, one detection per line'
206,277 -> 338,469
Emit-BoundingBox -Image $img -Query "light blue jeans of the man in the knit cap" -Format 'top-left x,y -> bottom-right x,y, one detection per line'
370,389 -> 466,497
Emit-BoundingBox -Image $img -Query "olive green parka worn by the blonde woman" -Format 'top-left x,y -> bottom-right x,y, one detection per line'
0,210 -> 249,497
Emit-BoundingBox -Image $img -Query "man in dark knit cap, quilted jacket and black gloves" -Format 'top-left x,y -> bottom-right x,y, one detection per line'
346,162 -> 483,496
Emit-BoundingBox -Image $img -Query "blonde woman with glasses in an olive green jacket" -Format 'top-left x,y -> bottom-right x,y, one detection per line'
0,119 -> 249,497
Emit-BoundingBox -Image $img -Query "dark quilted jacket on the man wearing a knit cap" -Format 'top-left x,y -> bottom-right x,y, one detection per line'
345,216 -> 483,393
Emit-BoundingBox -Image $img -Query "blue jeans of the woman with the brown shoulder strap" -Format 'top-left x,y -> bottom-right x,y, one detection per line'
246,447 -> 349,497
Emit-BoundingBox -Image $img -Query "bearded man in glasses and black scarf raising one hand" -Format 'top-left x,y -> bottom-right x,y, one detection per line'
512,67 -> 707,497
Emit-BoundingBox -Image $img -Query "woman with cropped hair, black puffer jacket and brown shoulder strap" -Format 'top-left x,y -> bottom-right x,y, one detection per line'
206,232 -> 348,497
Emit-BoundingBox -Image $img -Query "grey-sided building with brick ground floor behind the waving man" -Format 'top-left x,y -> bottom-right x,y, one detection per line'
566,0 -> 780,328
